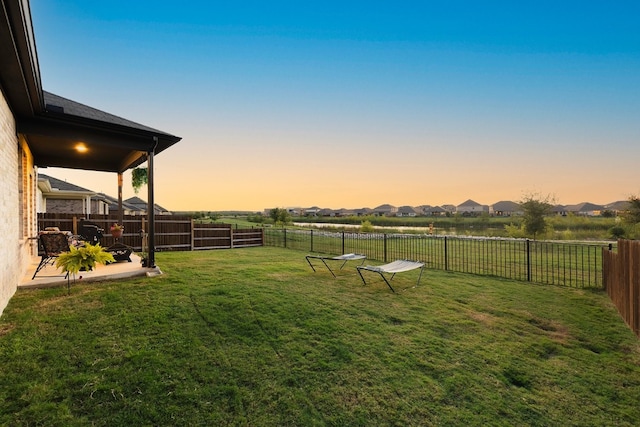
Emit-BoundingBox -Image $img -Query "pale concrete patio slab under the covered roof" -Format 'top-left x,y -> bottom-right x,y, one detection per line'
18,254 -> 162,289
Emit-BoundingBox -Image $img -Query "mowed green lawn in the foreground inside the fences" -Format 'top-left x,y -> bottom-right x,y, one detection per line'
0,247 -> 640,426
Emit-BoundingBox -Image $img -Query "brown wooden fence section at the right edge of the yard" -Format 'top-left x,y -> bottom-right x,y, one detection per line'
602,240 -> 640,337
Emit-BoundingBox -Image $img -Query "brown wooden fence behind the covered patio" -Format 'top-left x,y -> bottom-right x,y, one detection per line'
38,213 -> 264,251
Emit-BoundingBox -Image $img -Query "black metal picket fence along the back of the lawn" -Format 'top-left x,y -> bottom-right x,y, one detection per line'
264,228 -> 610,288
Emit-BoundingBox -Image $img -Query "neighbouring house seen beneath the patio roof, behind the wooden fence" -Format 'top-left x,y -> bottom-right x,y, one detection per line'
36,173 -> 109,216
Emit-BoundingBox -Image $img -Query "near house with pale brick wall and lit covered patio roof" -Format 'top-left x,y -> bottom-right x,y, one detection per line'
0,0 -> 181,314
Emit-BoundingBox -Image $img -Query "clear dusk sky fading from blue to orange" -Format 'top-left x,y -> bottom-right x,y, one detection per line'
31,0 -> 640,211
